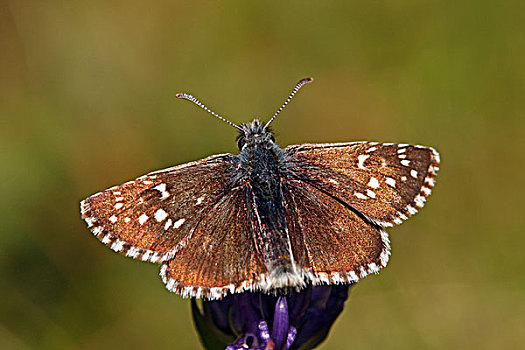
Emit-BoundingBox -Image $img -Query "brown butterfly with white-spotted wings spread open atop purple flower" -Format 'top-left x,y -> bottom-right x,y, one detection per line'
81,78 -> 439,300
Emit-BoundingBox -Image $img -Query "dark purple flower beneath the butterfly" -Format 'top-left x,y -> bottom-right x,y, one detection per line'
191,285 -> 351,350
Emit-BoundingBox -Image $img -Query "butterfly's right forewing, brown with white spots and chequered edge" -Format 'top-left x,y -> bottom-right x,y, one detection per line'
285,142 -> 439,227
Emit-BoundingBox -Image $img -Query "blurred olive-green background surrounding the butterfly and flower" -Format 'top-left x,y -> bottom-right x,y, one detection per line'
0,0 -> 525,349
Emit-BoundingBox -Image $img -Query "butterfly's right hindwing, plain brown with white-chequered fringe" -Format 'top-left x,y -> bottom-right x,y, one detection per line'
283,179 -> 390,284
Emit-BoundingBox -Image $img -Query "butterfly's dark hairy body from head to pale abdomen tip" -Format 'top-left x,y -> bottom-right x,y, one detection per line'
234,119 -> 303,288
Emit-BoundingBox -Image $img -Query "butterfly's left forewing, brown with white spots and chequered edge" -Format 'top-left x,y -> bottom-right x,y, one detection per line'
81,154 -> 235,262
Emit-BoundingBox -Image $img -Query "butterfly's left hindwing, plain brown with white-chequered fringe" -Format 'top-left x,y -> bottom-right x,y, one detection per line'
160,187 -> 266,299
